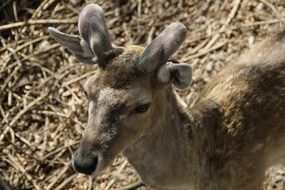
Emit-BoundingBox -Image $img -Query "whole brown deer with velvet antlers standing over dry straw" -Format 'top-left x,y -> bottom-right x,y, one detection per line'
48,4 -> 285,190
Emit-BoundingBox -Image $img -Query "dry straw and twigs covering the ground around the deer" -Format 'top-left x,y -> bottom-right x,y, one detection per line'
0,0 -> 285,190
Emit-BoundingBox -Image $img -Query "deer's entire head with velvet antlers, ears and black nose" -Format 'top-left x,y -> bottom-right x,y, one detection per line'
48,4 -> 192,175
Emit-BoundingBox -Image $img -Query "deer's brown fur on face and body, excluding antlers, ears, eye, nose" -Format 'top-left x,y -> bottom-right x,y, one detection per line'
77,34 -> 285,190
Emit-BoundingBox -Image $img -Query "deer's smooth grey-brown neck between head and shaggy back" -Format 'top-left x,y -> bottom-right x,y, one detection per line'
124,89 -> 220,189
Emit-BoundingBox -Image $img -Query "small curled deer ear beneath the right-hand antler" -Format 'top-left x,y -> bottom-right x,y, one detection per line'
157,62 -> 192,89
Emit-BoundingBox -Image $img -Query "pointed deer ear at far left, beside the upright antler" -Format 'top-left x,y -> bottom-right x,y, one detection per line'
48,27 -> 95,64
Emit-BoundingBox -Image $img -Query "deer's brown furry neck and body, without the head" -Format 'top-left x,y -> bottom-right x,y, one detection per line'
124,34 -> 285,190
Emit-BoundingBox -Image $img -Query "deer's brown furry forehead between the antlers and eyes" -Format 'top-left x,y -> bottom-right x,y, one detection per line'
83,46 -> 151,97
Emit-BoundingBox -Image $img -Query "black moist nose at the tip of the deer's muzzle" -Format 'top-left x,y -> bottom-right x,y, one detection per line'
72,152 -> 98,175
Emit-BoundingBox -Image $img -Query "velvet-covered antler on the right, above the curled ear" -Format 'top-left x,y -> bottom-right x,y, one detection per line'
138,23 -> 187,72
